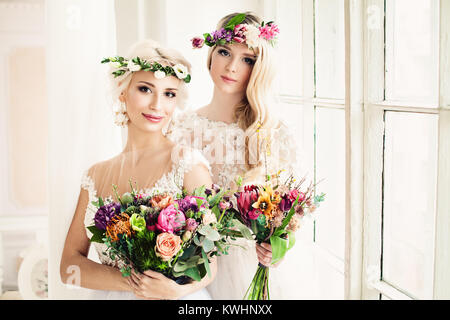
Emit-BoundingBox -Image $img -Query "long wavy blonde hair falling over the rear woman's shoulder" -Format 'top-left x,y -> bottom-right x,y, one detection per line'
206,12 -> 279,177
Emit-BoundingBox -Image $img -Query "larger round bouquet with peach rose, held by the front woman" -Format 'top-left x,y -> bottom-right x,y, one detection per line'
88,183 -> 249,284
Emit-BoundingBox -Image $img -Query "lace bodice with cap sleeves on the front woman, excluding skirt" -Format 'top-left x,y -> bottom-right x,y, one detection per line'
81,148 -> 211,268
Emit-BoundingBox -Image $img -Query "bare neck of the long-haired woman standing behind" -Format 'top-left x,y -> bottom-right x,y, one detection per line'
207,86 -> 244,123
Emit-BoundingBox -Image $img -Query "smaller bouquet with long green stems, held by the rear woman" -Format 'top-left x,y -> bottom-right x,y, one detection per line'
235,172 -> 325,300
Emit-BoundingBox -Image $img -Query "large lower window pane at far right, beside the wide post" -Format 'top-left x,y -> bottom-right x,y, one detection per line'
382,112 -> 438,299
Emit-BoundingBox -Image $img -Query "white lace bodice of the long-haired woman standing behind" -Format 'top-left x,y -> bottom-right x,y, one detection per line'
166,111 -> 303,190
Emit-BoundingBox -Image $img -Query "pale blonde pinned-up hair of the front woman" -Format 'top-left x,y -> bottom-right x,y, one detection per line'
109,39 -> 191,108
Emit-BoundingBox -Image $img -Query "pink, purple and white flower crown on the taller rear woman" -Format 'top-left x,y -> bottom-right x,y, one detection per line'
191,13 -> 280,49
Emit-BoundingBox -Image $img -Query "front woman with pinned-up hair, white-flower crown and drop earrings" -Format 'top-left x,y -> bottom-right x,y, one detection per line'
60,40 -> 217,299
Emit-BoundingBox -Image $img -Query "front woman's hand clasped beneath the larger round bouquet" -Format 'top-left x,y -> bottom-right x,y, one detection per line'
128,270 -> 185,300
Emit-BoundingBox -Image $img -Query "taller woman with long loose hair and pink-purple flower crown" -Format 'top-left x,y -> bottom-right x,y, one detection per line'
166,12 -> 299,299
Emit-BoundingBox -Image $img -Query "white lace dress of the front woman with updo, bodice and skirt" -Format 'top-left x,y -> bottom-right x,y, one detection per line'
81,149 -> 211,300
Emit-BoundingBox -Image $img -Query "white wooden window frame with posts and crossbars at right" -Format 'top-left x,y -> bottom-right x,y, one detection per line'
270,0 -> 450,300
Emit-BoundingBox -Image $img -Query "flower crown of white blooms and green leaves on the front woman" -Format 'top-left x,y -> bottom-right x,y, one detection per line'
102,57 -> 191,83
